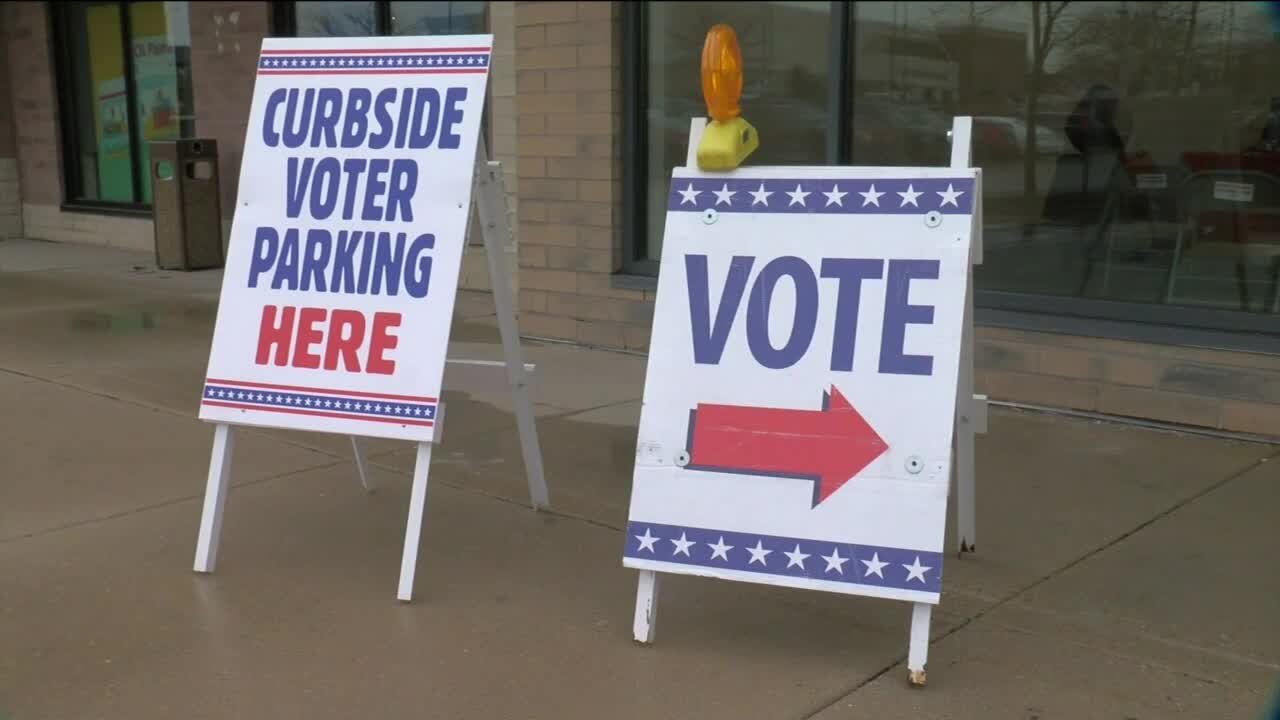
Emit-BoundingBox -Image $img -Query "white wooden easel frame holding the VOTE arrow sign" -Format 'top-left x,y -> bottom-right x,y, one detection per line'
632,117 -> 987,685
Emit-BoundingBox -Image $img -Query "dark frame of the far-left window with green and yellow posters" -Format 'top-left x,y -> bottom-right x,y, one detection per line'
46,0 -> 152,217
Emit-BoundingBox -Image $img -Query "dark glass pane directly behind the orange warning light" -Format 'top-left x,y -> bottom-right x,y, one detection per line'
643,1 -> 835,260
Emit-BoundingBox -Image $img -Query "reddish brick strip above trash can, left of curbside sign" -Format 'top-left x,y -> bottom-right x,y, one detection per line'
189,1 -> 270,251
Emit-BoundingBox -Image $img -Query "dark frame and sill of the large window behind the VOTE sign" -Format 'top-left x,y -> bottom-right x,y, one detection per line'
614,0 -> 1280,340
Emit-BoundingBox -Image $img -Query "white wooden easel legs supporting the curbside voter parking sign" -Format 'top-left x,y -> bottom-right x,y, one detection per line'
195,138 -> 550,602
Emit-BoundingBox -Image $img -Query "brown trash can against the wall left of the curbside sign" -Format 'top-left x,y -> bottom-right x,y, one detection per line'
150,138 -> 224,270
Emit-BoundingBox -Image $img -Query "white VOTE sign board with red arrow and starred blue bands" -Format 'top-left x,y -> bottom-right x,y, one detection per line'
623,168 -> 977,602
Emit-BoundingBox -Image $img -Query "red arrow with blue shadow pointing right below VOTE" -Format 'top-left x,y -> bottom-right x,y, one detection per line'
687,386 -> 888,507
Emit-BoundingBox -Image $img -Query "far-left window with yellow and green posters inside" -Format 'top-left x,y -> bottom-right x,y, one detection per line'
52,3 -> 195,209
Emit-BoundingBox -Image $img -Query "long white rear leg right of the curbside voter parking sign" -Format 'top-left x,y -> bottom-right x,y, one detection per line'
476,143 -> 552,510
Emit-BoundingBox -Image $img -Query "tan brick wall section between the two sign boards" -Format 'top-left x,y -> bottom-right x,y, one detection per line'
516,1 -> 653,350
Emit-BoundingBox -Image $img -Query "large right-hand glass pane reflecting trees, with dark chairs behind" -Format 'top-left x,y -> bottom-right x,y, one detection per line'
854,1 -> 1280,313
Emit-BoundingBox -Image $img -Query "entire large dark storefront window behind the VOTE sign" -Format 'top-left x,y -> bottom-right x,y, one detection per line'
625,0 -> 1280,334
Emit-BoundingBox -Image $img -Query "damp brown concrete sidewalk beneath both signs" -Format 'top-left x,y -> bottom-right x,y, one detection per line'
0,241 -> 1280,720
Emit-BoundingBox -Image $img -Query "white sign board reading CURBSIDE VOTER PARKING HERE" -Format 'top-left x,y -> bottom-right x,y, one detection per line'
200,35 -> 493,441
